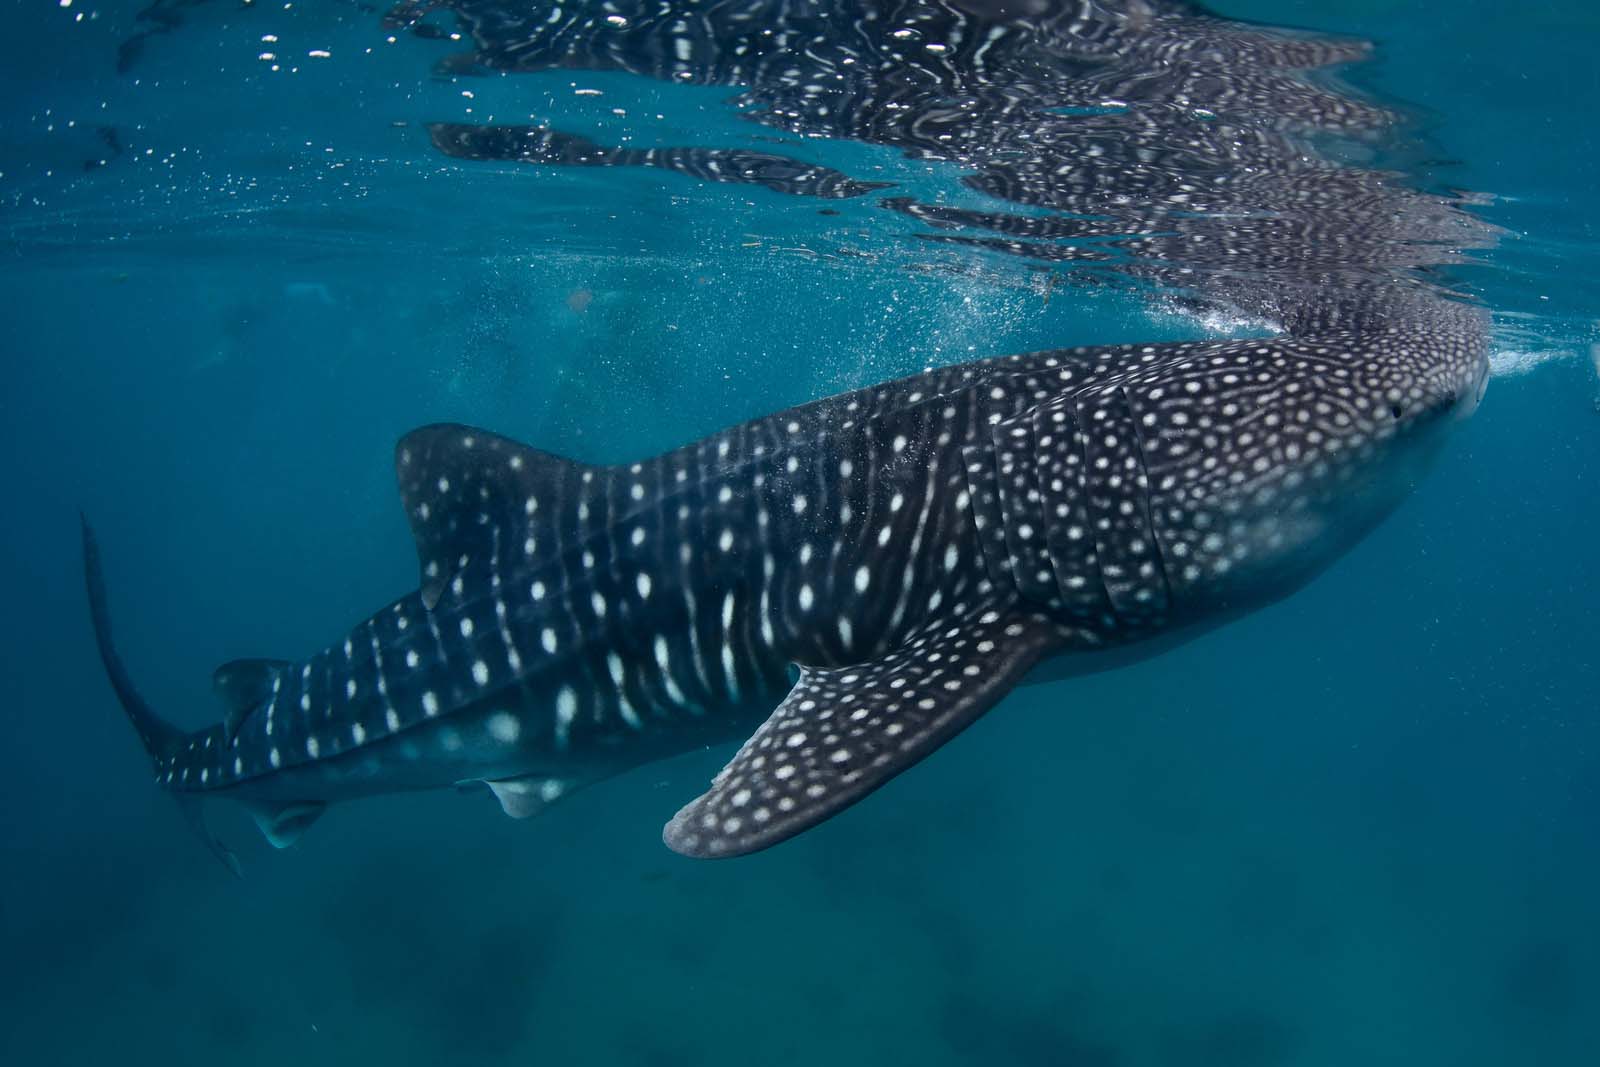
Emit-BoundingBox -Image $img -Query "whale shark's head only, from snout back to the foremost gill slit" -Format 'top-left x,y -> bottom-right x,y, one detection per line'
1128,323 -> 1488,609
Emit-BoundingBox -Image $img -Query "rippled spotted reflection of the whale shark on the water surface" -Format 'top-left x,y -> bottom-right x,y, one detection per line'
387,0 -> 1494,333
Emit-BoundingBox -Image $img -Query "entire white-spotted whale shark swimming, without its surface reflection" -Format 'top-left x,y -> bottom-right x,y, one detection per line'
85,304 -> 1486,856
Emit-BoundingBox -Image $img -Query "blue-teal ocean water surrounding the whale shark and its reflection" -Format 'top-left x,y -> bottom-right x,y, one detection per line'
0,0 -> 1600,1067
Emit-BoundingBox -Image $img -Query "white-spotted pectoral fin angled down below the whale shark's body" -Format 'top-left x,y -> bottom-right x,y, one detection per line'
661,605 -> 1062,857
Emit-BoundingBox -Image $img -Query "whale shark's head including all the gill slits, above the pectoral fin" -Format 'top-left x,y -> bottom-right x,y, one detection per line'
970,306 -> 1488,633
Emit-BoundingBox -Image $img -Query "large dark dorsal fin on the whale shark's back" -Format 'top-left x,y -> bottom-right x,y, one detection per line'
395,422 -> 603,609
